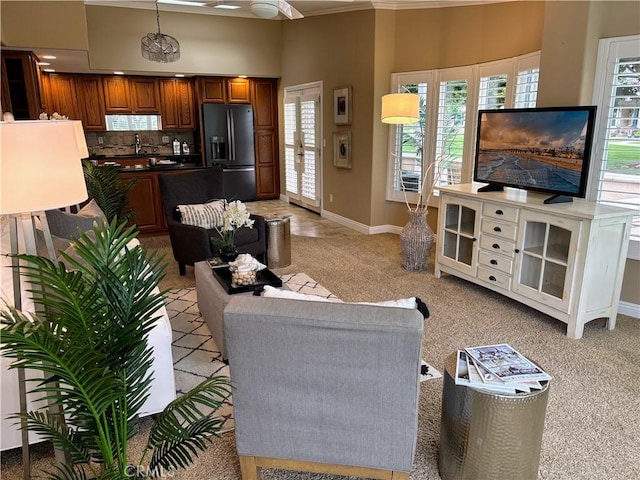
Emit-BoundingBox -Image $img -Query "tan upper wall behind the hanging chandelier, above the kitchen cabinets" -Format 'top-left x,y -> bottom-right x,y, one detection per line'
87,6 -> 281,77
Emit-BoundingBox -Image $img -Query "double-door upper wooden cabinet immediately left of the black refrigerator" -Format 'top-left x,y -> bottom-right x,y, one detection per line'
160,78 -> 196,130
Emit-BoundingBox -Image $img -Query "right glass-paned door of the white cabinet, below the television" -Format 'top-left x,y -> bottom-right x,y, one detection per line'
513,212 -> 580,312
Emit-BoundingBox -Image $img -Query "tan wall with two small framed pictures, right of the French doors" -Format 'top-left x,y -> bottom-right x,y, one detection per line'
281,10 -> 379,224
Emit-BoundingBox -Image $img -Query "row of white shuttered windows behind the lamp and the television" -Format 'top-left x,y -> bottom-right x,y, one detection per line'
386,53 -> 540,205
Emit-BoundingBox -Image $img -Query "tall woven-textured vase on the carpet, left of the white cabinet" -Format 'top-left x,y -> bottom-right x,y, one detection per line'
400,211 -> 435,272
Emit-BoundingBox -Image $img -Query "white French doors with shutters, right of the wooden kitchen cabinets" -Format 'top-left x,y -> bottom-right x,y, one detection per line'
284,83 -> 322,212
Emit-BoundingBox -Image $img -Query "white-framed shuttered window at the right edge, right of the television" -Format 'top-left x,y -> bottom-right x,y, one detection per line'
590,35 -> 640,255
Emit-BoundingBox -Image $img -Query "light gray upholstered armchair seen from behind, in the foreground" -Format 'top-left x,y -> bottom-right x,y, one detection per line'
224,295 -> 424,480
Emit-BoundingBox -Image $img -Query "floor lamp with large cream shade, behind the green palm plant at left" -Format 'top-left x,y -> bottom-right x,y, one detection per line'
0,120 -> 89,479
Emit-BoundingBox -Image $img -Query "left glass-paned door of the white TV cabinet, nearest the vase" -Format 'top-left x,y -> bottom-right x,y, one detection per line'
439,197 -> 479,275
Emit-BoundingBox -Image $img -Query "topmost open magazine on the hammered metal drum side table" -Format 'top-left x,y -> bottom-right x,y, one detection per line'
465,343 -> 551,383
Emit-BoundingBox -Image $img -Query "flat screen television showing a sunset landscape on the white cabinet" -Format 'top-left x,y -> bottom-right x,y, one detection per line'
473,106 -> 596,203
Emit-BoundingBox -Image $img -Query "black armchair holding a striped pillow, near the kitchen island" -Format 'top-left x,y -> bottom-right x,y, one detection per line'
158,168 -> 267,275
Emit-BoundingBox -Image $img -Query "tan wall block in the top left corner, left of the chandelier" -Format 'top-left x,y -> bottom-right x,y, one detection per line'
0,0 -> 89,50
